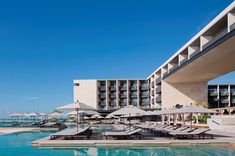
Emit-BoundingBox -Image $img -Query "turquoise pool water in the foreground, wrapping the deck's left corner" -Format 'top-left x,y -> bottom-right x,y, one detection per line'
0,132 -> 235,156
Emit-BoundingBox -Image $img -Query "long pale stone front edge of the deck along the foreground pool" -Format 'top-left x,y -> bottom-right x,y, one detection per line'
32,133 -> 235,148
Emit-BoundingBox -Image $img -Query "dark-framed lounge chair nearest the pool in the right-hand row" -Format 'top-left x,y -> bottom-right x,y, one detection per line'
169,128 -> 213,139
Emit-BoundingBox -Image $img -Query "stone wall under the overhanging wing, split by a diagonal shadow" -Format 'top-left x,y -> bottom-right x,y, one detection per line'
162,80 -> 208,108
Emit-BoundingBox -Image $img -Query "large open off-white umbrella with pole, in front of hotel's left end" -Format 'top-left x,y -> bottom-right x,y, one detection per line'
57,102 -> 96,131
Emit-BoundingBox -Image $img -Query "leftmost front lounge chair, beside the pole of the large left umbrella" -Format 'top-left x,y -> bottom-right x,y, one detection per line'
50,127 -> 92,140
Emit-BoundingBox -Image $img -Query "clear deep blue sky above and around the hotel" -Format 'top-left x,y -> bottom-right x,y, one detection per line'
0,0 -> 235,117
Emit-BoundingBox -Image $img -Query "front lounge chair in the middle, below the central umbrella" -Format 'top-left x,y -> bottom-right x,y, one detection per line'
103,128 -> 143,139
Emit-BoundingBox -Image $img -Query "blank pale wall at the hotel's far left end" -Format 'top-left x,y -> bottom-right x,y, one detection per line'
74,80 -> 97,108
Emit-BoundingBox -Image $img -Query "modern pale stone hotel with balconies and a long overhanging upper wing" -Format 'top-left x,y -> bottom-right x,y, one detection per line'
74,2 -> 235,110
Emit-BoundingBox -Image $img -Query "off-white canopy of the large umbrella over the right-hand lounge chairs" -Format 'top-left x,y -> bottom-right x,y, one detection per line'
175,106 -> 217,114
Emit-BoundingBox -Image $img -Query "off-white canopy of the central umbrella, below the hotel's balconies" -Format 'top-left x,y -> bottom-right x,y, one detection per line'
110,107 -> 146,116
